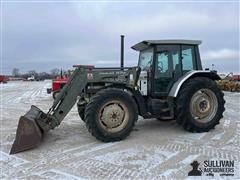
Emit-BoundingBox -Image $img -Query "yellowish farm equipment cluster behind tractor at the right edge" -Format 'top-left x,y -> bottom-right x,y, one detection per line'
217,73 -> 240,92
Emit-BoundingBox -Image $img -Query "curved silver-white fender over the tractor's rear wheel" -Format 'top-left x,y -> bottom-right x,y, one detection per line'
168,71 -> 221,97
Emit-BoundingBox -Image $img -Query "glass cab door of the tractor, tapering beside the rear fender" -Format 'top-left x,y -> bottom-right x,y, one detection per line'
152,45 -> 182,96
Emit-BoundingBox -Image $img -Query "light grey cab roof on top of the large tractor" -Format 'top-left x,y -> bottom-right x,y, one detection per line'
131,39 -> 202,51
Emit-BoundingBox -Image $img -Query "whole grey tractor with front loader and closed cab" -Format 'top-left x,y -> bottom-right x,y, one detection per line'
10,36 -> 225,154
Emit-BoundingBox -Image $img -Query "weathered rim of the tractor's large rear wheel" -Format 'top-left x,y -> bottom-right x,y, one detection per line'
190,89 -> 218,123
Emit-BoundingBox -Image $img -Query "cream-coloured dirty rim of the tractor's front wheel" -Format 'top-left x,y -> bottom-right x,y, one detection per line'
98,100 -> 129,133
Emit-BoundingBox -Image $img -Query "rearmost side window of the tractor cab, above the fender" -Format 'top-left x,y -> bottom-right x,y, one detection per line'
182,45 -> 196,71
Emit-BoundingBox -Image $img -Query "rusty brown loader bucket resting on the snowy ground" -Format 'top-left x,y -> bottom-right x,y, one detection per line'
10,106 -> 45,154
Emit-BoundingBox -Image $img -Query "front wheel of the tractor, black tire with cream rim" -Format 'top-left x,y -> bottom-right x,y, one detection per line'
85,88 -> 138,142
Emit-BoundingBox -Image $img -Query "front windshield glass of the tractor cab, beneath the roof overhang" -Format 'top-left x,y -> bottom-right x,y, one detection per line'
138,48 -> 153,71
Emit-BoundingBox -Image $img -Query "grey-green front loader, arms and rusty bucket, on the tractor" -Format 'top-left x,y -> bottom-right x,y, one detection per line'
10,65 -> 139,154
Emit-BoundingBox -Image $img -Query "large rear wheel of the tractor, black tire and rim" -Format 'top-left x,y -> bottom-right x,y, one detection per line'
175,77 -> 225,132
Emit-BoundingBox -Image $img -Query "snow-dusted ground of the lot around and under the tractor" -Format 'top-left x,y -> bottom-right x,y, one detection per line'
0,81 -> 240,179
